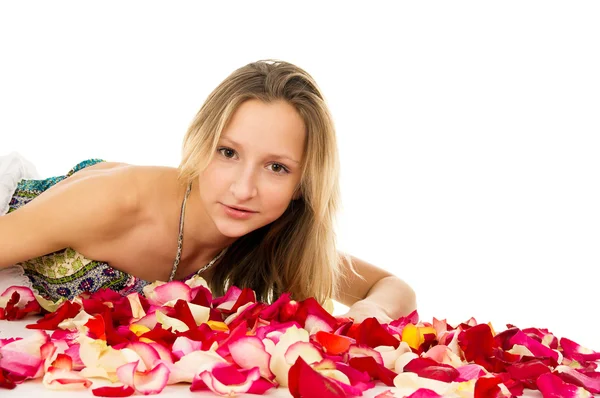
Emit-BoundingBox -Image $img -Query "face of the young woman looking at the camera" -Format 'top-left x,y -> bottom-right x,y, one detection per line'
199,99 -> 306,238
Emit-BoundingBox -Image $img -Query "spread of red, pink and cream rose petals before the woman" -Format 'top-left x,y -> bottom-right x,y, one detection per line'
0,277 -> 600,398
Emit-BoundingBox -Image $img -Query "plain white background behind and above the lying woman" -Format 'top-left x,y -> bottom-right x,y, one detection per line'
0,1 -> 600,358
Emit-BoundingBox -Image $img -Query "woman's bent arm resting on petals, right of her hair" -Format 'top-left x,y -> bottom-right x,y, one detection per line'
335,253 -> 417,322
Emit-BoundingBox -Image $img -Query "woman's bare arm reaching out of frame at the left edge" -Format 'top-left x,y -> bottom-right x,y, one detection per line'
0,172 -> 137,268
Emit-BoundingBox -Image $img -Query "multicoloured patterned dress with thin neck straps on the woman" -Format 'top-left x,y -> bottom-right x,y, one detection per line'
8,159 -> 225,301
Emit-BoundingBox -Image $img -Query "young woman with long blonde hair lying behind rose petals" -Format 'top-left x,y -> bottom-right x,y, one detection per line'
0,60 -> 416,322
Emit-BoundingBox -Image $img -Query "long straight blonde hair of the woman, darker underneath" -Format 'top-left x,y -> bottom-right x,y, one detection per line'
179,60 -> 351,303
